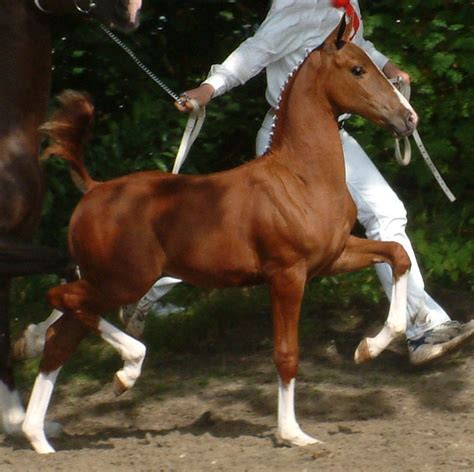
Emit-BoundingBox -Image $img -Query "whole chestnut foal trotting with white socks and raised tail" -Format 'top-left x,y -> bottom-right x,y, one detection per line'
23,21 -> 418,453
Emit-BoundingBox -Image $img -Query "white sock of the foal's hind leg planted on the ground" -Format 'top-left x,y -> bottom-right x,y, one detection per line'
23,369 -> 60,454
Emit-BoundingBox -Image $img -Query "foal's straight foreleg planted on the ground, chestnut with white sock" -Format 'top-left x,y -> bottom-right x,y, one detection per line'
270,264 -> 319,446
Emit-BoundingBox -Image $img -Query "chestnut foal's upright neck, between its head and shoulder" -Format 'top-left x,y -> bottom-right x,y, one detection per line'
270,58 -> 345,190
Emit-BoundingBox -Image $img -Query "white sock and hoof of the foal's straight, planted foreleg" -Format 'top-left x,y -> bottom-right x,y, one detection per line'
278,377 -> 321,446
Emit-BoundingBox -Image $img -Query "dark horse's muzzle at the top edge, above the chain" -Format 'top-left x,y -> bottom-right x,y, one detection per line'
34,0 -> 142,32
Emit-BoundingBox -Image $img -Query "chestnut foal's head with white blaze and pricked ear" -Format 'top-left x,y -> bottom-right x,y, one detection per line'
318,18 -> 418,136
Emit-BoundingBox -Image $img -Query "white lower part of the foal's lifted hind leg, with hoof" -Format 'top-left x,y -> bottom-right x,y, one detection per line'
98,318 -> 146,389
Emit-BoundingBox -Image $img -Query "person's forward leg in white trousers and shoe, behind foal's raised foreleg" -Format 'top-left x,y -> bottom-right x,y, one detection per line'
341,130 -> 474,364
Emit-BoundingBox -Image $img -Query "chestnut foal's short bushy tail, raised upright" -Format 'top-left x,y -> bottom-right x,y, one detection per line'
40,90 -> 99,193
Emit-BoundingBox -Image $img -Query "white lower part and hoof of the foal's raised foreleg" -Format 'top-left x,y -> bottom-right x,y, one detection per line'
354,271 -> 408,363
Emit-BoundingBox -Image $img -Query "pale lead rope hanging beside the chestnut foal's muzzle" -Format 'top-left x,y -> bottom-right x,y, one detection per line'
391,77 -> 456,202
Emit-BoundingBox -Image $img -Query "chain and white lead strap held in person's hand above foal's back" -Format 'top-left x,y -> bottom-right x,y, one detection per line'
100,24 -> 206,174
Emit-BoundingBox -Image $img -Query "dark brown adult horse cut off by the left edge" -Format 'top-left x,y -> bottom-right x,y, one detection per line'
0,0 -> 141,434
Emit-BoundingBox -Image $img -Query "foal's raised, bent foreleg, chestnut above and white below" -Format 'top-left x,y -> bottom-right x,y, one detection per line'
329,236 -> 410,364
